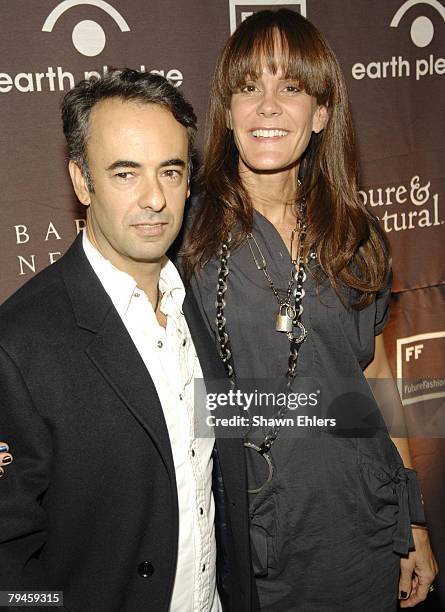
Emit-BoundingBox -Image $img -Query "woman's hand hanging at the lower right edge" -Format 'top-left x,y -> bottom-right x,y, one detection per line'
399,527 -> 439,608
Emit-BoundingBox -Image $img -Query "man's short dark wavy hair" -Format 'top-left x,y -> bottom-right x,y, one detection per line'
62,68 -> 196,191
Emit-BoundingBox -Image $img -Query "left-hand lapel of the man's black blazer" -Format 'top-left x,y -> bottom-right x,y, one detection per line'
58,235 -> 175,483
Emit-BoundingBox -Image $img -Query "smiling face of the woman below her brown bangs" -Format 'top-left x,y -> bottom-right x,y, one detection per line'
227,70 -> 327,173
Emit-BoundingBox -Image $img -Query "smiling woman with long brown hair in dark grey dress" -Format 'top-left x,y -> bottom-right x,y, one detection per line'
183,9 -> 437,612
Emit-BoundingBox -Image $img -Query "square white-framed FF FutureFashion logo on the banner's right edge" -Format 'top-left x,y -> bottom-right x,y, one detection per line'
397,331 -> 445,406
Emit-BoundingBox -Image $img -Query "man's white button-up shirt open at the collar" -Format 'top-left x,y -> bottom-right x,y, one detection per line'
83,231 -> 221,612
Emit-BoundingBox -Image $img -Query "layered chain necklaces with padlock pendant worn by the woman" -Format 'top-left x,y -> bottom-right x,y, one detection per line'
216,201 -> 310,493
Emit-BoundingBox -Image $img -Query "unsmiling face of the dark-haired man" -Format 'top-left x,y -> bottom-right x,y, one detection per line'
70,98 -> 189,274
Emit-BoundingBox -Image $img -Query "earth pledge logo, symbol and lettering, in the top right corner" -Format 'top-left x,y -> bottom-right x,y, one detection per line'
351,0 -> 445,81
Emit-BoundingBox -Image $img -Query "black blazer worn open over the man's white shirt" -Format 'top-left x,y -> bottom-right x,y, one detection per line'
0,237 -> 257,612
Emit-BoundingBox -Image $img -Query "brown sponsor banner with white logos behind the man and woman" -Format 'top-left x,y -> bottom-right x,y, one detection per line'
0,0 -> 445,609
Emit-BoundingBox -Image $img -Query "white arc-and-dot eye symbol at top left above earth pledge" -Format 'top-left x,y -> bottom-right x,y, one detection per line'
42,0 -> 130,57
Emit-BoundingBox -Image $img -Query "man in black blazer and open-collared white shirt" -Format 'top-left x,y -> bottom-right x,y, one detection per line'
0,70 -> 253,612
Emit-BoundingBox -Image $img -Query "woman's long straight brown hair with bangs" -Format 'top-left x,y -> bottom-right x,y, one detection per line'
183,9 -> 389,308
